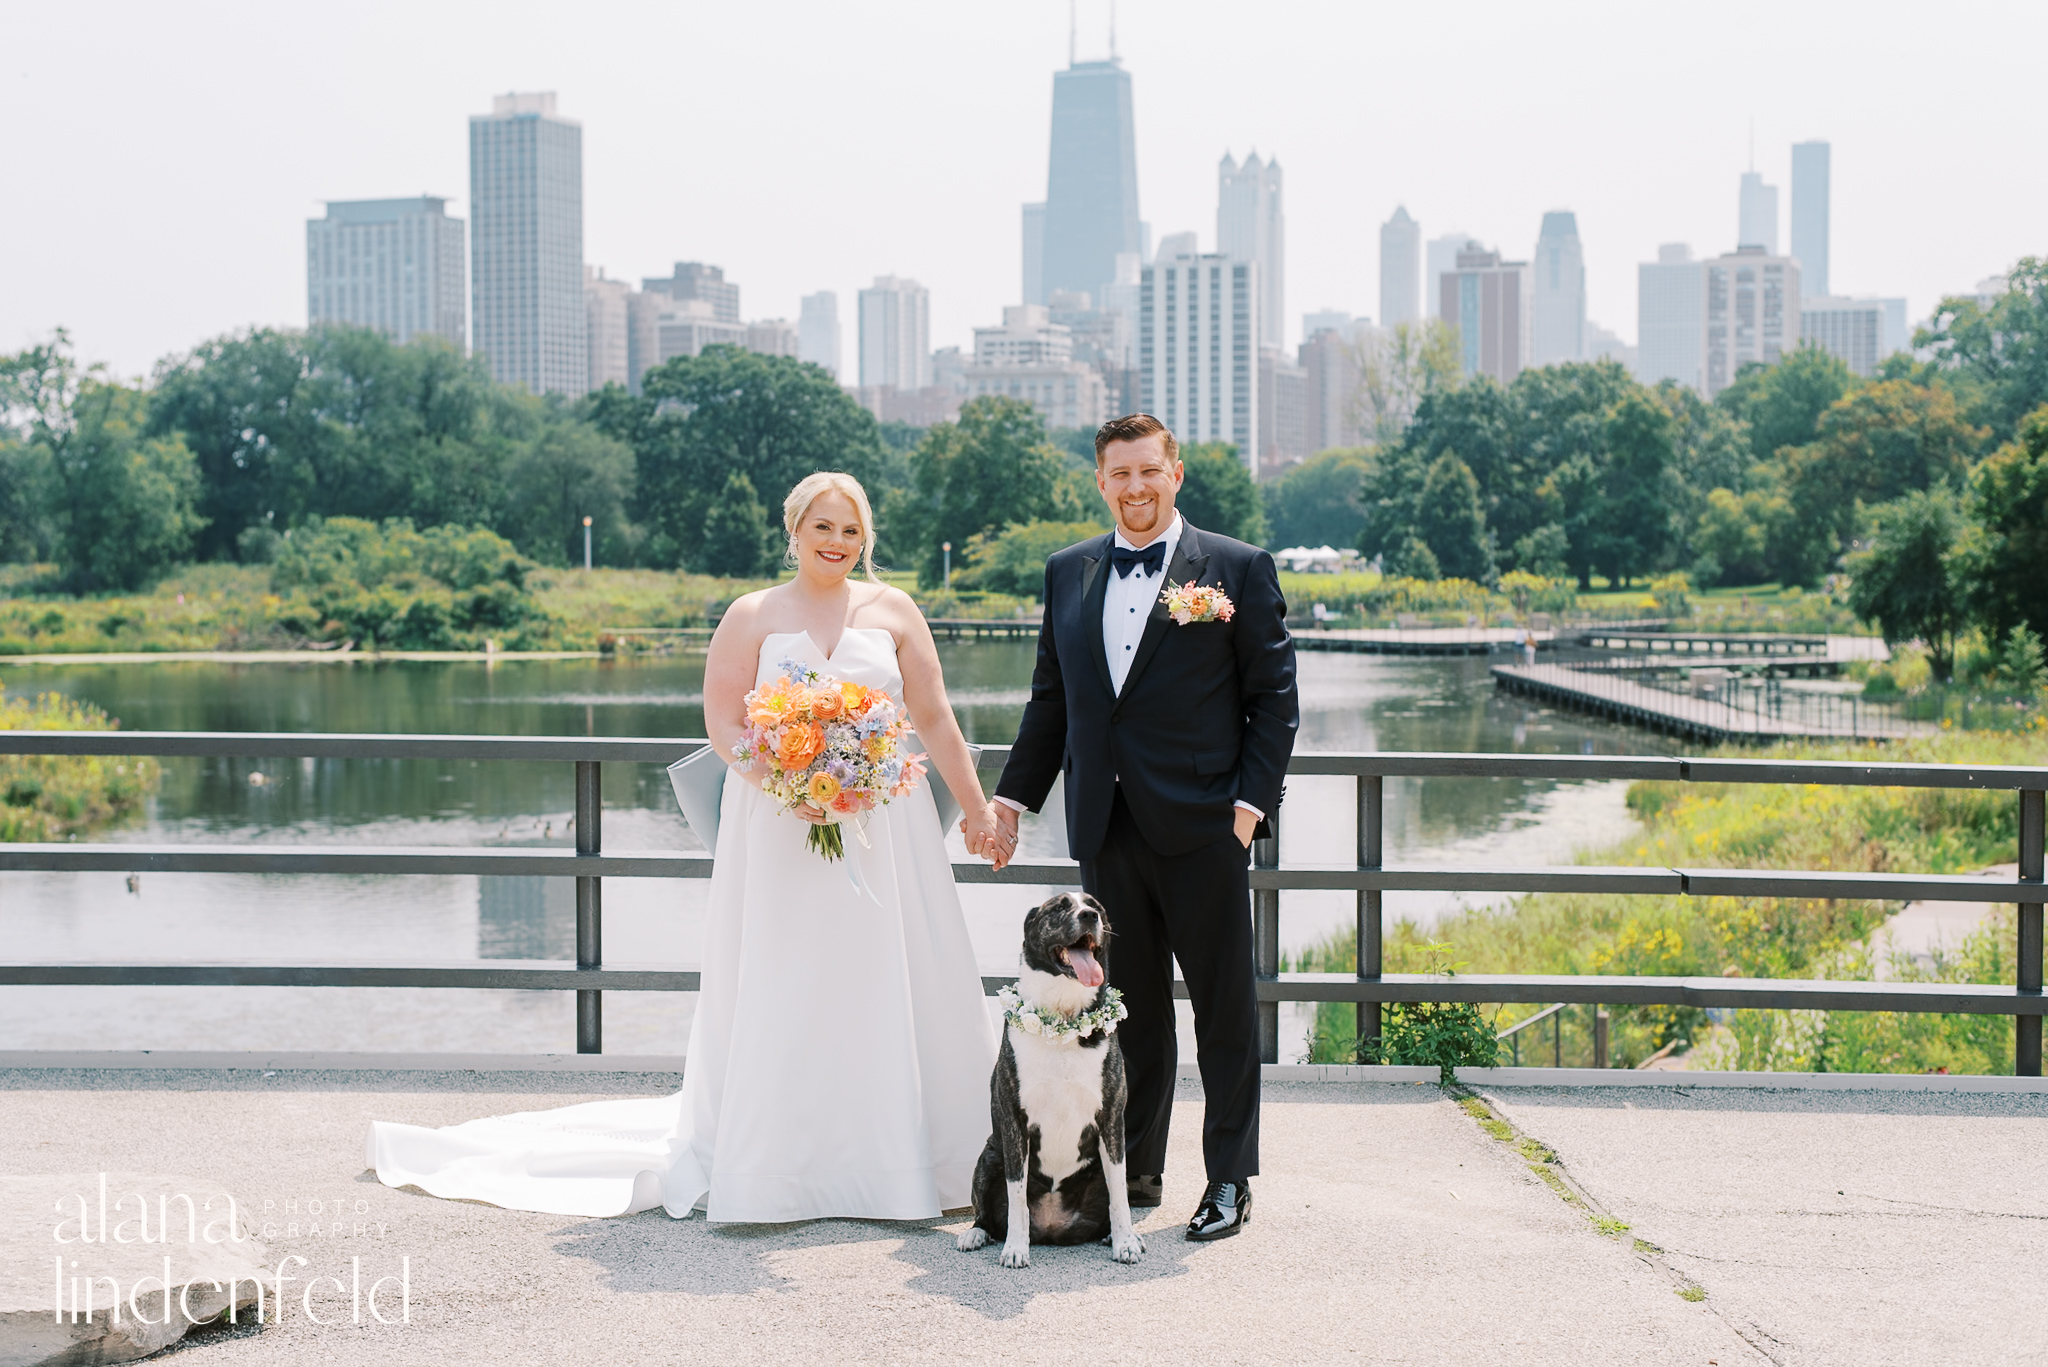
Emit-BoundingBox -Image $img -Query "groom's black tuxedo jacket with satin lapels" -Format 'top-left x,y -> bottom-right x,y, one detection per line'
995,521 -> 1300,859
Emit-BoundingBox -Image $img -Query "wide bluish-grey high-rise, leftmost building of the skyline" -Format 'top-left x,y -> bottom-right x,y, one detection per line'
305,195 -> 469,350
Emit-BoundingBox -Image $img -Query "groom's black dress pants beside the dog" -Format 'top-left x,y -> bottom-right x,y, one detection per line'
1081,785 -> 1260,1183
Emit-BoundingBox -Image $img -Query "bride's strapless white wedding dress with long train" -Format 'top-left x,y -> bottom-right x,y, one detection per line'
369,627 -> 995,1221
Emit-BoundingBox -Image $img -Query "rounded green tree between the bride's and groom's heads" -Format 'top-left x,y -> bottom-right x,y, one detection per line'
887,396 -> 1085,588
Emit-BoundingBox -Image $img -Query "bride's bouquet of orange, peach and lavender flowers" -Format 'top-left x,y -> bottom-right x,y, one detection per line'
733,660 -> 924,859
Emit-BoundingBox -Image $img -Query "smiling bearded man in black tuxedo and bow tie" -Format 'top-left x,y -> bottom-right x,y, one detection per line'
995,414 -> 1298,1240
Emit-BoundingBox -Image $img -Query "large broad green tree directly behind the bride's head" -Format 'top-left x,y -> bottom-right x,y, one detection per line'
592,346 -> 887,566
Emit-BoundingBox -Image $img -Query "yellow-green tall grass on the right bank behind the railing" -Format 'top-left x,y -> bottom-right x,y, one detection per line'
1288,721 -> 2048,1072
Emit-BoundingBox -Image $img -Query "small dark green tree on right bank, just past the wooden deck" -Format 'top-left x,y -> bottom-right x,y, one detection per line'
1849,488 -> 1968,678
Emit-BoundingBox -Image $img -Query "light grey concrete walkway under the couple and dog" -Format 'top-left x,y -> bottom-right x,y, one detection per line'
0,1060 -> 2048,1367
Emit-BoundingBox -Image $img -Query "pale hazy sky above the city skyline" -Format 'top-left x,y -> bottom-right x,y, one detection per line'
0,0 -> 2048,375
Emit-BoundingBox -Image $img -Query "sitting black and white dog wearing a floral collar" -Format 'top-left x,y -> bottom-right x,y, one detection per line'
961,892 -> 1145,1267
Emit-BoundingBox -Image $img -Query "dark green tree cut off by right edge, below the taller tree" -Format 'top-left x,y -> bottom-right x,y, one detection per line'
1964,404 -> 2048,635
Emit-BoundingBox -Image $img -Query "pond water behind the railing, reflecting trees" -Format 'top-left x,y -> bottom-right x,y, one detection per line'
0,641 -> 1659,1058
